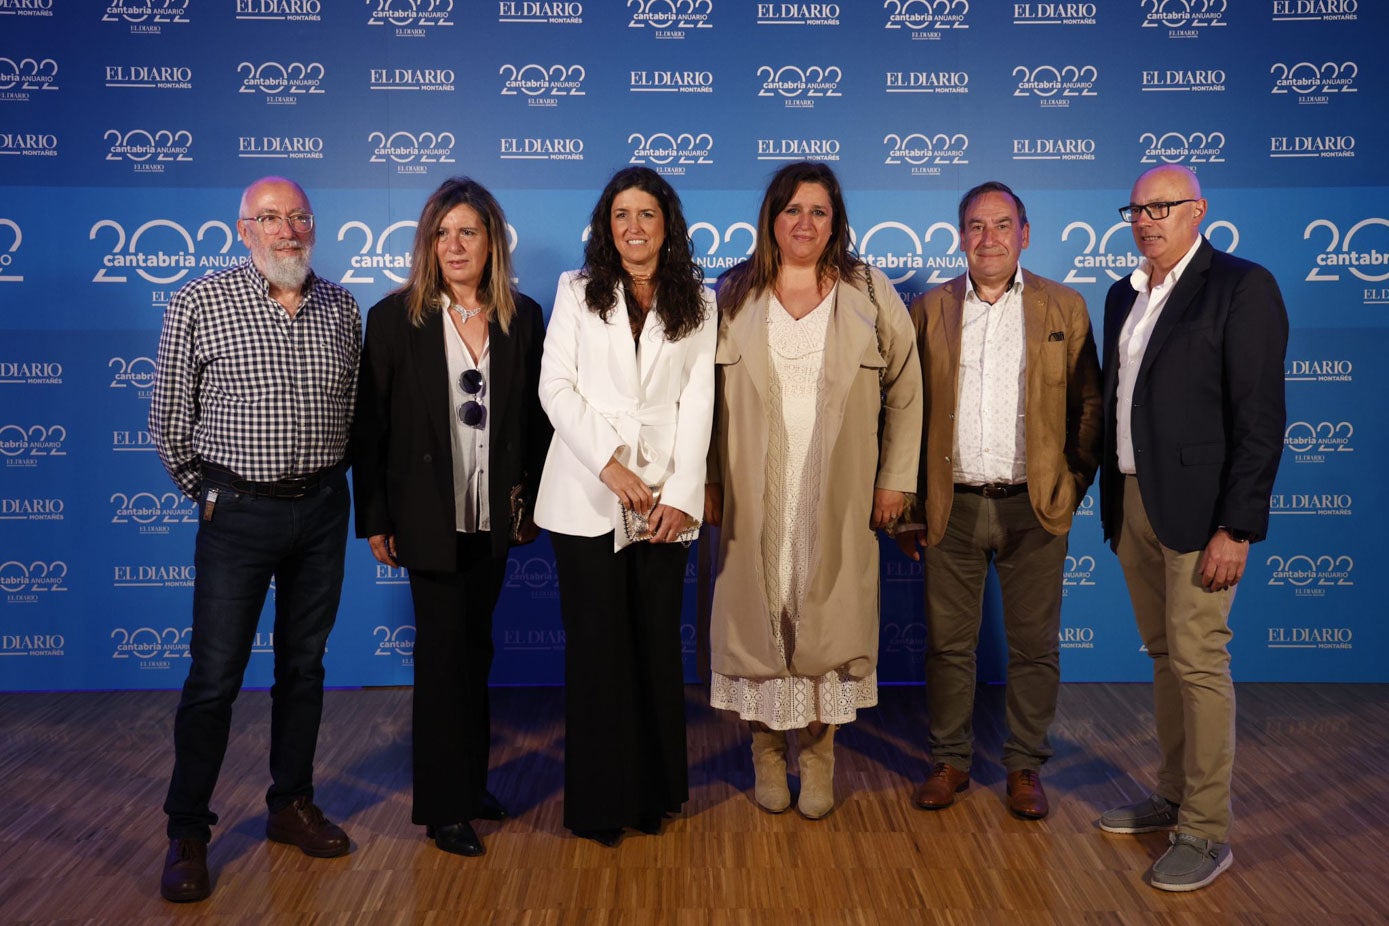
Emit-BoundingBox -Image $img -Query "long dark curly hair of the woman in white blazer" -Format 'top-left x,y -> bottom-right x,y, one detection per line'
579,167 -> 704,342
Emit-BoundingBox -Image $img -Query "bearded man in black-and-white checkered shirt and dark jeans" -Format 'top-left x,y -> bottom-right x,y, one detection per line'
150,176 -> 361,901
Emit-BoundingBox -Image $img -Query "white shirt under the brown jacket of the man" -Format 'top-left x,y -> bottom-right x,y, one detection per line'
954,267 -> 1028,486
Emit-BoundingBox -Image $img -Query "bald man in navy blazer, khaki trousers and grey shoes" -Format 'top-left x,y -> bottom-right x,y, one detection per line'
1100,165 -> 1288,891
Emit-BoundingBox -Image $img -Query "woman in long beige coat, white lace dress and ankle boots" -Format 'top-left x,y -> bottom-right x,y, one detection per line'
704,162 -> 921,819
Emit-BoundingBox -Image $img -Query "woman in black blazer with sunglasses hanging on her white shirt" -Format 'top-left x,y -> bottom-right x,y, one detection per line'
353,178 -> 550,855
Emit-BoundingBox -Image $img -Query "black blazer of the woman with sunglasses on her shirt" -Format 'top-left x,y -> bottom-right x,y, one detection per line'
351,293 -> 550,571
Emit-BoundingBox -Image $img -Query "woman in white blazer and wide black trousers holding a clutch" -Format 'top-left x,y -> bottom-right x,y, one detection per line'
535,168 -> 717,845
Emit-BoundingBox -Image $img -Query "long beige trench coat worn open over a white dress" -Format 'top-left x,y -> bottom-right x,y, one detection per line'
708,271 -> 922,679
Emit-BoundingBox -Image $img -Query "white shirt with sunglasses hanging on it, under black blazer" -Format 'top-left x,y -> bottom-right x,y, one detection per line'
439,305 -> 492,533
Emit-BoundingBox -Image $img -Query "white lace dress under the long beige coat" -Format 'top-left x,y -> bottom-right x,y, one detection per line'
710,287 -> 878,730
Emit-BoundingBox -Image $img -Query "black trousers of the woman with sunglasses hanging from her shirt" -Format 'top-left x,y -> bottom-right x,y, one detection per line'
410,532 -> 507,826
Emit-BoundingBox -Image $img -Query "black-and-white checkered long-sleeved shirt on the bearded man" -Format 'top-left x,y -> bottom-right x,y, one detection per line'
150,258 -> 361,497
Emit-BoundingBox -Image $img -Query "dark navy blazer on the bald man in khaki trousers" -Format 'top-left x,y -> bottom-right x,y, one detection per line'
1100,239 -> 1288,553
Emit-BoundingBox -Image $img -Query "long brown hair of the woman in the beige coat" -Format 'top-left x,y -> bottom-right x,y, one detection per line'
718,161 -> 867,318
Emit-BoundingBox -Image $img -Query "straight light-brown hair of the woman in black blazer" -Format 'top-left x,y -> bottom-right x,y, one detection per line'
396,176 -> 517,332
